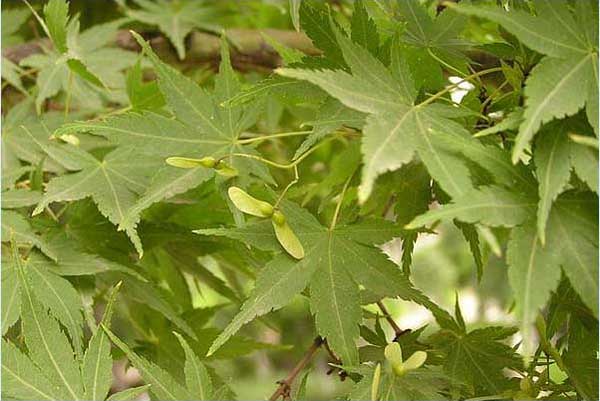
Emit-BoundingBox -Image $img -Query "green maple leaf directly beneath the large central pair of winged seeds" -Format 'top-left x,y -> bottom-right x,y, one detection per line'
197,198 -> 450,364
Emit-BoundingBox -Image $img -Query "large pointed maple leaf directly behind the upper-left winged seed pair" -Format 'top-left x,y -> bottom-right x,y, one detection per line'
56,34 -> 272,255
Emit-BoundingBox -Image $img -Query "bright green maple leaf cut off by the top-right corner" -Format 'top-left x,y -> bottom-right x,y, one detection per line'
453,0 -> 598,162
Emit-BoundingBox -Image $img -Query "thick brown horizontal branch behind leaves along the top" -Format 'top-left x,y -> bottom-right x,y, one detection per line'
2,28 -> 320,71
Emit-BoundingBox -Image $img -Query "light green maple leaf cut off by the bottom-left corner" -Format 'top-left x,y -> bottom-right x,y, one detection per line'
2,252 -> 118,400
